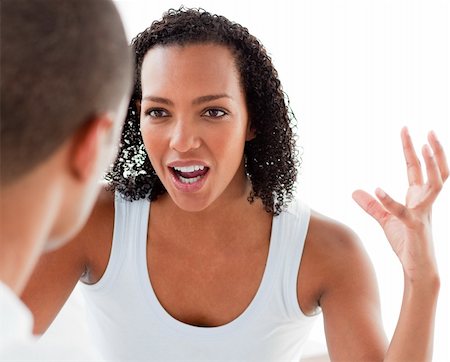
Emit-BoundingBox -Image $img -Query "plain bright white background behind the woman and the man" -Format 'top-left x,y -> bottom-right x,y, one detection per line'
40,0 -> 450,361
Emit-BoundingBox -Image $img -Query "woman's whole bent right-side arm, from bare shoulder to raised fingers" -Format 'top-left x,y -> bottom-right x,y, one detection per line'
306,129 -> 449,361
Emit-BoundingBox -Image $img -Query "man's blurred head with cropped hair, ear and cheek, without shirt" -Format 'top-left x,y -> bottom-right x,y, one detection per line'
0,0 -> 132,246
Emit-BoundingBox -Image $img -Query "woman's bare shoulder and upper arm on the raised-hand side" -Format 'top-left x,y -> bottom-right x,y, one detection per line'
304,216 -> 388,361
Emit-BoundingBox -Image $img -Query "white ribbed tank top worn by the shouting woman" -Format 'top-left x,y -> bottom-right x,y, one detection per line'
80,194 -> 316,362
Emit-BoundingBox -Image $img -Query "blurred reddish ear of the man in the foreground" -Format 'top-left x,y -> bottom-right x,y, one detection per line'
69,114 -> 113,181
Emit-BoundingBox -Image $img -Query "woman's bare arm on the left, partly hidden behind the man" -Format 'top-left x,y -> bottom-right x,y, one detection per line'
21,191 -> 114,334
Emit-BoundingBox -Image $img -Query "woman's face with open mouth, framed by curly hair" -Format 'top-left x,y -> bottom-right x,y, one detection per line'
140,44 -> 252,211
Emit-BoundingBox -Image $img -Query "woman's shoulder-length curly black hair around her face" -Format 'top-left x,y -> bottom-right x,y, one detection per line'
106,7 -> 299,215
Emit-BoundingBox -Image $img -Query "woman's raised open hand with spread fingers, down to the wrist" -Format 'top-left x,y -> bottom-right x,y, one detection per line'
353,128 -> 449,282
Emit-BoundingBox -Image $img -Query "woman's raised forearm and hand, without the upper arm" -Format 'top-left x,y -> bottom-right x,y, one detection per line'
353,128 -> 449,361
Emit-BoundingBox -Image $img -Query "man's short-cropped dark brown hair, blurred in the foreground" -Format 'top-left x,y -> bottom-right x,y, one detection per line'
0,0 -> 132,185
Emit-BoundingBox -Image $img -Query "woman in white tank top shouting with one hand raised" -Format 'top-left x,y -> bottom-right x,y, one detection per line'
25,9 -> 449,361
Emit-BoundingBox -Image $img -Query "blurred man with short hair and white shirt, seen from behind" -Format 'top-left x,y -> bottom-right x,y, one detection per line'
0,0 -> 132,360
